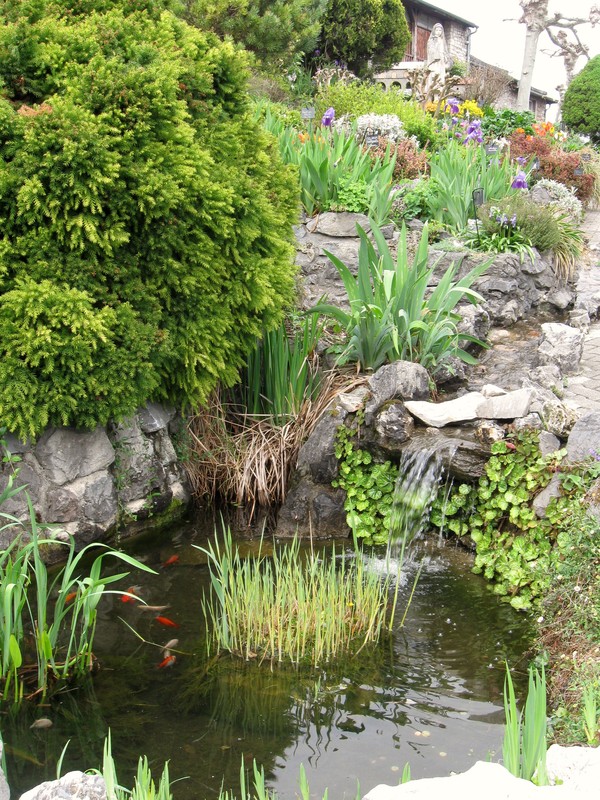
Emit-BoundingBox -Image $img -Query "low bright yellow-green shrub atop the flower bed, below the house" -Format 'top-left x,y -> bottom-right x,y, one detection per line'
315,81 -> 437,146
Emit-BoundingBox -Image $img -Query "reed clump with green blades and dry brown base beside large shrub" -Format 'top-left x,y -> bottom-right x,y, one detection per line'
186,315 -> 364,517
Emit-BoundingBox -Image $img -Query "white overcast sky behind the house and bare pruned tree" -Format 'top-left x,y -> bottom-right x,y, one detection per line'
428,0 -> 600,111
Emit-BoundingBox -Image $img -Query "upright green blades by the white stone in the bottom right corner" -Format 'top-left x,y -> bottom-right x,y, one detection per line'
502,664 -> 548,786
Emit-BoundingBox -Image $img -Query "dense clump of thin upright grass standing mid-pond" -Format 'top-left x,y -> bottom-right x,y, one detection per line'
200,529 -> 394,667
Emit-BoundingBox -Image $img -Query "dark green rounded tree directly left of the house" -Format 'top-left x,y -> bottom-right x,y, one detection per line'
320,0 -> 410,75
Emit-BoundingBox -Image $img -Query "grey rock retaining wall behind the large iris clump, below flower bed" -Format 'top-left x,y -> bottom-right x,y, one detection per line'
296,212 -> 575,326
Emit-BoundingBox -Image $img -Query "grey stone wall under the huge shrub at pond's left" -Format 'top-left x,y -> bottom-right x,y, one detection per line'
0,403 -> 190,557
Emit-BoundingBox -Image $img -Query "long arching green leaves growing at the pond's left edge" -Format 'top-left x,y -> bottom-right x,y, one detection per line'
0,498 -> 153,703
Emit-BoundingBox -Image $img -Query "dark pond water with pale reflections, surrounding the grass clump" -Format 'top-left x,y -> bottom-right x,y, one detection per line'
2,520 -> 531,800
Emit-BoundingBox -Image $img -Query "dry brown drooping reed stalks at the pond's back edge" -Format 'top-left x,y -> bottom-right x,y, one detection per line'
186,371 -> 366,517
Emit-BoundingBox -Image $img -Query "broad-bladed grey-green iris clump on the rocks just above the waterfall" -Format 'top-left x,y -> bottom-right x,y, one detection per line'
310,224 -> 490,375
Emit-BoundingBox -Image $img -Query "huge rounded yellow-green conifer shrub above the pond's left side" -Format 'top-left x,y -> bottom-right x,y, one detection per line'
0,0 -> 297,436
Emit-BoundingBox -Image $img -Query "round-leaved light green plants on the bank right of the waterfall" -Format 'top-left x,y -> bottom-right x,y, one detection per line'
431,431 -> 600,609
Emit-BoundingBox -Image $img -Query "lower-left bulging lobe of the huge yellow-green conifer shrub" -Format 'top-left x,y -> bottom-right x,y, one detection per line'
0,279 -> 161,439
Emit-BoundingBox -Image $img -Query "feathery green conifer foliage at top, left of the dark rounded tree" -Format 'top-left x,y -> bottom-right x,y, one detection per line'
181,0 -> 326,71
